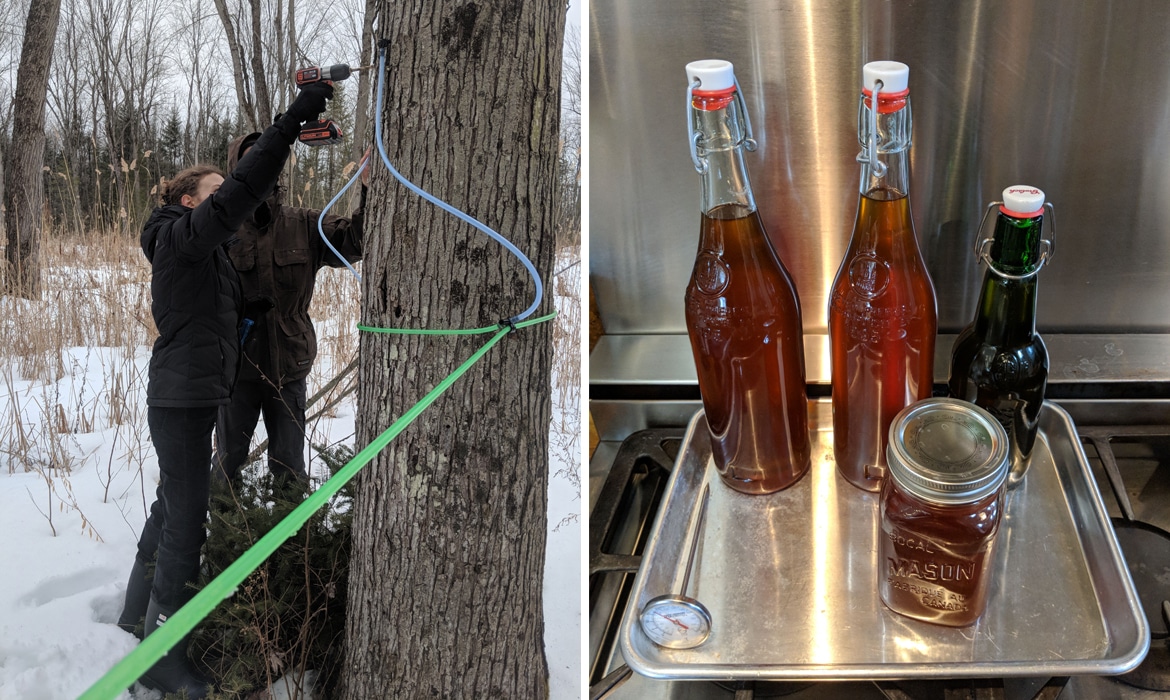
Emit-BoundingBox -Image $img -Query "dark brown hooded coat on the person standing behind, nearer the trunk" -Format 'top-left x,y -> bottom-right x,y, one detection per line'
221,133 -> 365,386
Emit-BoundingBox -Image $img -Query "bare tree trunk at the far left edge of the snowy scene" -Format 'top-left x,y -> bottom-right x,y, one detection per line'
4,0 -> 61,298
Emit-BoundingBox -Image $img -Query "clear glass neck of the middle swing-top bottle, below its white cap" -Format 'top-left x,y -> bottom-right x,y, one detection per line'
858,91 -> 913,200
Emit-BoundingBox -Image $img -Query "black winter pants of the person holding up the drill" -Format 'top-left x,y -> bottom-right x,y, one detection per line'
138,406 -> 218,610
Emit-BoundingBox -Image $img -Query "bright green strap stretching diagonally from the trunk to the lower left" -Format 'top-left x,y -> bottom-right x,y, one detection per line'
78,313 -> 556,700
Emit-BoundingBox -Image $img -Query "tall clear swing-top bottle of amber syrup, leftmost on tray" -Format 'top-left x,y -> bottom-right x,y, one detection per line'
686,61 -> 812,494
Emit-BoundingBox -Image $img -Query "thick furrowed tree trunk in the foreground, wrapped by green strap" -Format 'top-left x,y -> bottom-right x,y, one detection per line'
342,0 -> 566,699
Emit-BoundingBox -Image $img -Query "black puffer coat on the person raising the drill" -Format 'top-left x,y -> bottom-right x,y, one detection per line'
142,122 -> 300,407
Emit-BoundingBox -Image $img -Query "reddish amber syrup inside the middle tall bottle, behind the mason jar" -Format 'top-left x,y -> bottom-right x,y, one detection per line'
828,188 -> 938,490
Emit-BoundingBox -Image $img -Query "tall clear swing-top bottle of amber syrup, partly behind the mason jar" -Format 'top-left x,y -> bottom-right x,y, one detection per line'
828,61 -> 938,490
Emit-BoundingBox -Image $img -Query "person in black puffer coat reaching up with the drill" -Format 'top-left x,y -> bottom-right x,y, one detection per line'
118,83 -> 333,699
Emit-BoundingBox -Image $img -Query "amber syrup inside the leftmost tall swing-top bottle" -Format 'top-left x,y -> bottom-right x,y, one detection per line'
686,204 -> 812,494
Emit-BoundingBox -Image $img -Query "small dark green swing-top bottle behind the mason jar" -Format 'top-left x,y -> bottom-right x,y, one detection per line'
949,185 -> 1052,487
